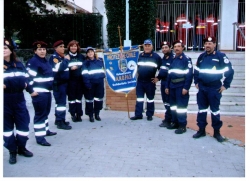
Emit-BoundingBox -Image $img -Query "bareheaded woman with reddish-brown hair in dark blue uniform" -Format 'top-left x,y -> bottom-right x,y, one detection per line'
65,40 -> 85,122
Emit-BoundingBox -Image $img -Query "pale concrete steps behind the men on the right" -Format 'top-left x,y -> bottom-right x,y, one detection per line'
155,51 -> 245,116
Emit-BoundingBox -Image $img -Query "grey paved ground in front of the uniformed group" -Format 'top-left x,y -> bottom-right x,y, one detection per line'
3,92 -> 246,178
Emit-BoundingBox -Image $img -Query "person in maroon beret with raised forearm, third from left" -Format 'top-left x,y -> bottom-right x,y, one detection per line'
49,40 -> 72,130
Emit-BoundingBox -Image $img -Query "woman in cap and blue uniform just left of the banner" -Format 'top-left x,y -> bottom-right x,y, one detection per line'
82,47 -> 105,122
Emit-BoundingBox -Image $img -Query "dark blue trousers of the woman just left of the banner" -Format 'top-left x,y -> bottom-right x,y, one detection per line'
84,79 -> 104,116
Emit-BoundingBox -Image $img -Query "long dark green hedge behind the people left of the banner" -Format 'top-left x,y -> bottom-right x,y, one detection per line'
18,13 -> 103,48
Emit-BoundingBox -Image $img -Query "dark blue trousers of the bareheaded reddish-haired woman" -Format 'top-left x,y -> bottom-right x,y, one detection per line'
68,79 -> 83,116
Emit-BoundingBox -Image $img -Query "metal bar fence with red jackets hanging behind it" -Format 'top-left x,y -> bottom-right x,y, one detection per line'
155,0 -> 245,50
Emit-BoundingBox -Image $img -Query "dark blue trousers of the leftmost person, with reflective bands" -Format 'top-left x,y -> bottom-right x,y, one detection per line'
3,92 -> 30,151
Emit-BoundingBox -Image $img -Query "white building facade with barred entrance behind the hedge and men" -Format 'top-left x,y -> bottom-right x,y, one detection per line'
93,0 -> 245,50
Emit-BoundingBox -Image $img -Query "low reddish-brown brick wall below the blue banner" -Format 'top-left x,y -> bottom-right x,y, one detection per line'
105,81 -> 136,113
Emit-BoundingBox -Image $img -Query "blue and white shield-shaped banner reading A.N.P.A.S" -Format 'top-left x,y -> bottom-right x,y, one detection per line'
104,47 -> 139,94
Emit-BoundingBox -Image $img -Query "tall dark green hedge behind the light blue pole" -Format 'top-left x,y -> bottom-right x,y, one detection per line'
105,0 -> 157,47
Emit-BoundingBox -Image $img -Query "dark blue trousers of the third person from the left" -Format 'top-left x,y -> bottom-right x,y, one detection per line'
53,83 -> 68,121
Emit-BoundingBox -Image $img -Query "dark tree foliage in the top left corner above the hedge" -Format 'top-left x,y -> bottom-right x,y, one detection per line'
4,0 -> 65,38
